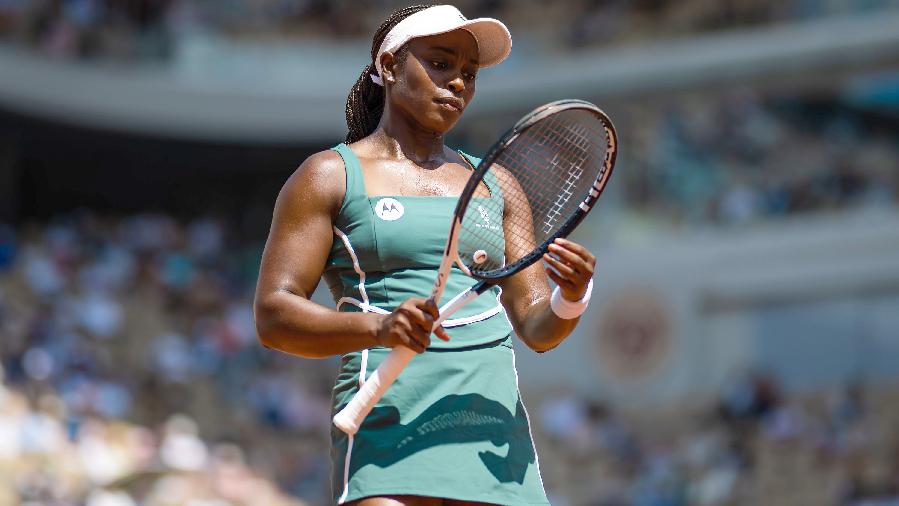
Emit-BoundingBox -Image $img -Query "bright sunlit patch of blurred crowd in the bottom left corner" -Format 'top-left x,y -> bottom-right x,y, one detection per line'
0,385 -> 307,506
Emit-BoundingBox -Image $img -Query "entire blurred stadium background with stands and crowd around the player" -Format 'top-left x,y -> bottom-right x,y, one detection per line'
0,0 -> 899,506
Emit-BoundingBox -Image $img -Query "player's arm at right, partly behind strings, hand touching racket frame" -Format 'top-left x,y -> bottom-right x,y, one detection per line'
497,166 -> 593,353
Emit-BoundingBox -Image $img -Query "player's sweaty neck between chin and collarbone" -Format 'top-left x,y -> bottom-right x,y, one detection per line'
374,107 -> 446,167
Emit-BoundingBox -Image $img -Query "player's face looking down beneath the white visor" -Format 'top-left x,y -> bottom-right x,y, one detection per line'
381,30 -> 478,134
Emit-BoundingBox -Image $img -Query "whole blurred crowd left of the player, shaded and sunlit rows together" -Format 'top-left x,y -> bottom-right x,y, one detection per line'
0,212 -> 335,505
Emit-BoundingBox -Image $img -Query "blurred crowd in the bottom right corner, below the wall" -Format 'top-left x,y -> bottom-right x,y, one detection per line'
537,374 -> 899,506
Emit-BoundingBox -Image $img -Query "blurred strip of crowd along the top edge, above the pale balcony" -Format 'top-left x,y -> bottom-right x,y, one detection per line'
0,0 -> 899,60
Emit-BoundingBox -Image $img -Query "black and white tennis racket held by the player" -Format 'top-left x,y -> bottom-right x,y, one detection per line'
334,100 -> 618,435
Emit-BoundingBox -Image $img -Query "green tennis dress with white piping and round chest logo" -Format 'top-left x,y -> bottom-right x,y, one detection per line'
324,144 -> 549,505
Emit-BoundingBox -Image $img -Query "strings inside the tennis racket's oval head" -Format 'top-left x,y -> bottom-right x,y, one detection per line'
458,109 -> 609,275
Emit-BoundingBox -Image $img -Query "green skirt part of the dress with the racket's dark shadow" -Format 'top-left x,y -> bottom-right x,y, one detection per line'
331,336 -> 549,505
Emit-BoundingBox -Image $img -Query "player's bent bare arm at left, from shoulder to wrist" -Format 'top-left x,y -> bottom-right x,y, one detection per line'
253,151 -> 381,358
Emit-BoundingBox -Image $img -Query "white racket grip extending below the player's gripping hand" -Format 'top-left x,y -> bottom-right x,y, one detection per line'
334,346 -> 416,436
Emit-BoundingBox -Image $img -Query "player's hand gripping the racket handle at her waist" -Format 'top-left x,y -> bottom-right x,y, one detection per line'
377,298 -> 449,353
